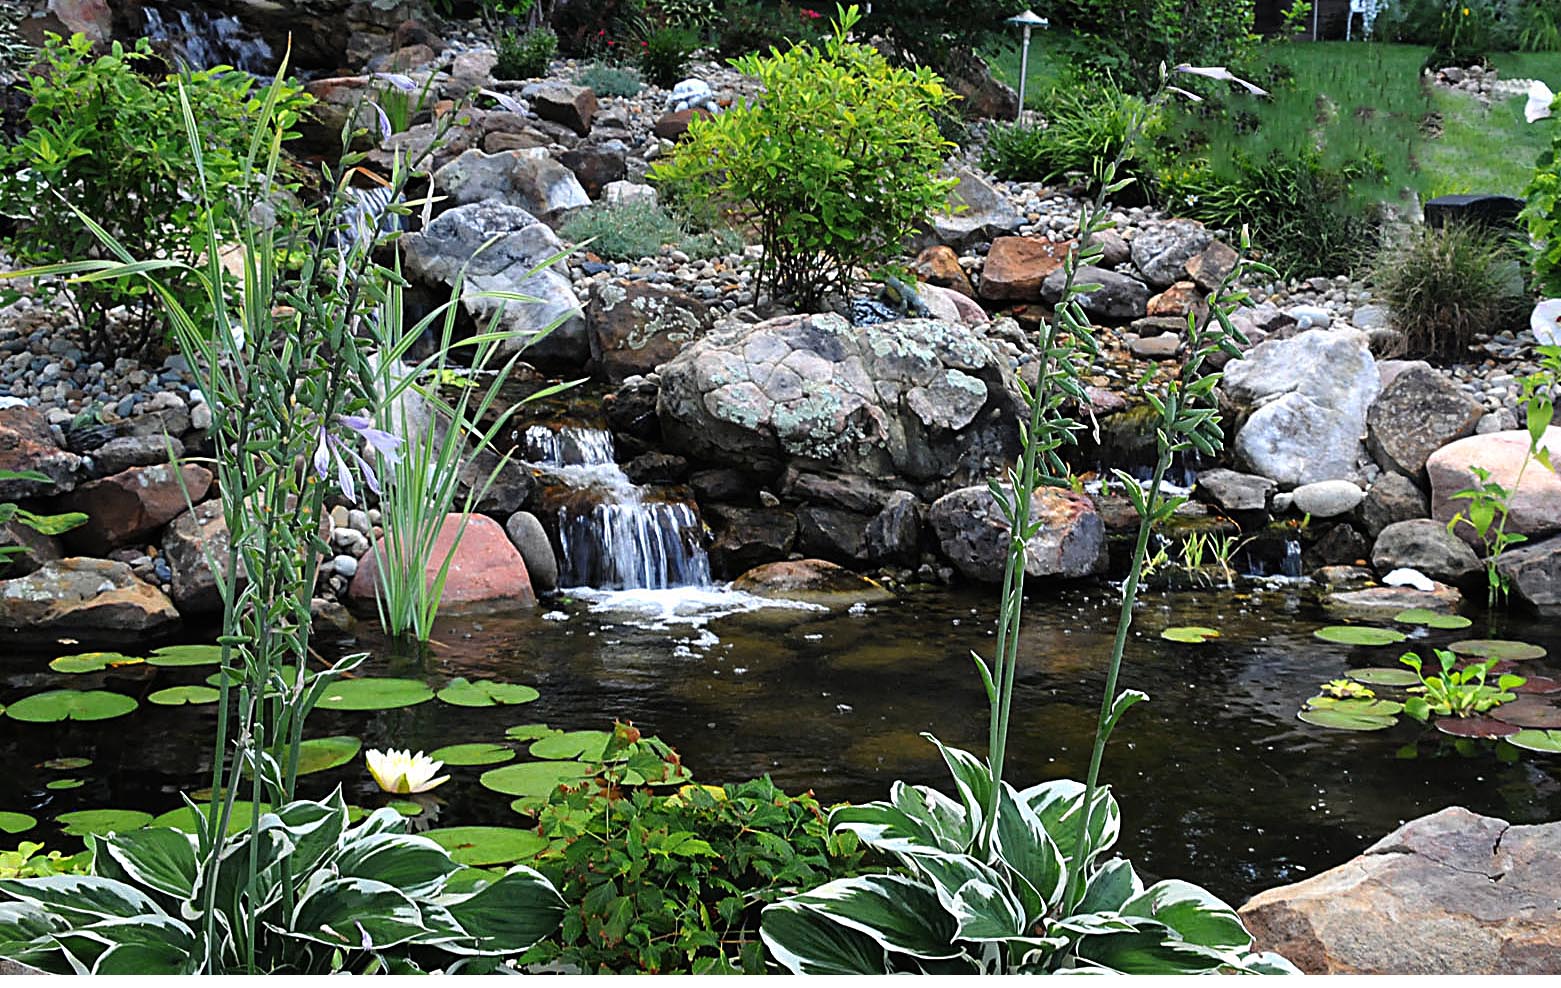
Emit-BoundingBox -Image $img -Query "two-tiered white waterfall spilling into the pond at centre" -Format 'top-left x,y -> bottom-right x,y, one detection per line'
523,426 -> 710,590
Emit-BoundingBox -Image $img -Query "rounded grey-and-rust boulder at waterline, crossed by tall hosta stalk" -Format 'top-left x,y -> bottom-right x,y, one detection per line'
929,487 -> 1107,584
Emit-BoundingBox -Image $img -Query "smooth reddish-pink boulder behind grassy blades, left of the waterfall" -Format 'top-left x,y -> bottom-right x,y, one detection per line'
347,515 -> 537,617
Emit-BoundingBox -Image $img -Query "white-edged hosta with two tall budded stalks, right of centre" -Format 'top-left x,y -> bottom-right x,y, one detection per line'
762,57 -> 1294,974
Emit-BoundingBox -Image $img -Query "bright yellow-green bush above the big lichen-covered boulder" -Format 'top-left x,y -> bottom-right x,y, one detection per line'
652,6 -> 954,307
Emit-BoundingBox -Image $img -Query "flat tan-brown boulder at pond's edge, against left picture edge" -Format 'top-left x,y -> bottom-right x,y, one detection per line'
0,557 -> 180,645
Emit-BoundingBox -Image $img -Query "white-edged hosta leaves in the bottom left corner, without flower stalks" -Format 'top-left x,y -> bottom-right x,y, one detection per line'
0,790 -> 564,974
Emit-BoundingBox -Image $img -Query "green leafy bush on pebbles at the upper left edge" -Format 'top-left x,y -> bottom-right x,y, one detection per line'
0,34 -> 312,357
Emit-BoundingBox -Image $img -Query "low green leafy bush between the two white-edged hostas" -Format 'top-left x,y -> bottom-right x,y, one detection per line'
523,779 -> 863,974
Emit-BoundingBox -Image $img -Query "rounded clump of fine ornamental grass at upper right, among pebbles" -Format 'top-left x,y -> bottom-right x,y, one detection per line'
1371,223 -> 1533,361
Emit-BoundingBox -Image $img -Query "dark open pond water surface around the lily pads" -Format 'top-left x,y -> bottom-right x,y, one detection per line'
0,581 -> 1561,901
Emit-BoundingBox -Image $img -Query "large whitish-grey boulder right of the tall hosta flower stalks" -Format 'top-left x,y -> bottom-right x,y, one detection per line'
1222,329 -> 1380,487
